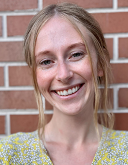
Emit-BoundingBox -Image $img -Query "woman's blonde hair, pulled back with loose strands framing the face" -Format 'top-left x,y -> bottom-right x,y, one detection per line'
24,3 -> 114,137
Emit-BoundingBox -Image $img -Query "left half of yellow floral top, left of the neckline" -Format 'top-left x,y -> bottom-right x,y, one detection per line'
0,131 -> 52,165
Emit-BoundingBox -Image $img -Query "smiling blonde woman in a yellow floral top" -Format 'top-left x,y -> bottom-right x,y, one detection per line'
0,3 -> 128,165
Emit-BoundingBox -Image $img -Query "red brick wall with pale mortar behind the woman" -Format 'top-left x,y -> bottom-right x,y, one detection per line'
0,0 -> 128,138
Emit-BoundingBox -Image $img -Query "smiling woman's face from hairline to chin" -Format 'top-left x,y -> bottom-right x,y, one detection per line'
35,16 -> 101,115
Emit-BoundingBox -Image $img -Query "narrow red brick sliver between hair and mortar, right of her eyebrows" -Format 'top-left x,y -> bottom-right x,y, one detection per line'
105,38 -> 113,59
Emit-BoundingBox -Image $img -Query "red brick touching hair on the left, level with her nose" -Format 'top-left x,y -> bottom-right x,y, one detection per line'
9,66 -> 32,86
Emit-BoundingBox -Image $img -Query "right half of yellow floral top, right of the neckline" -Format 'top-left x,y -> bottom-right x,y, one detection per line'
92,127 -> 128,165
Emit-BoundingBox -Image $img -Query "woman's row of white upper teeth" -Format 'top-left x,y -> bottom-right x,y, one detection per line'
57,86 -> 80,96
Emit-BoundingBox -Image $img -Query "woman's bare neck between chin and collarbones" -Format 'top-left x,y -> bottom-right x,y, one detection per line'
45,107 -> 99,146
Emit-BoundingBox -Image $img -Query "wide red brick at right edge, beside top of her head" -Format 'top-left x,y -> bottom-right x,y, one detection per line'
92,12 -> 128,33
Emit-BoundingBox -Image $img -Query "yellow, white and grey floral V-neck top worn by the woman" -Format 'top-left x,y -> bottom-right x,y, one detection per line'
0,127 -> 128,165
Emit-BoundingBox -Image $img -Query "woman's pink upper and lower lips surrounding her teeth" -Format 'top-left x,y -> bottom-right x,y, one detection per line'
51,83 -> 85,100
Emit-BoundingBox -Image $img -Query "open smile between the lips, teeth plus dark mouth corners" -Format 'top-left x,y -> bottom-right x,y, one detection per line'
54,84 -> 83,96
